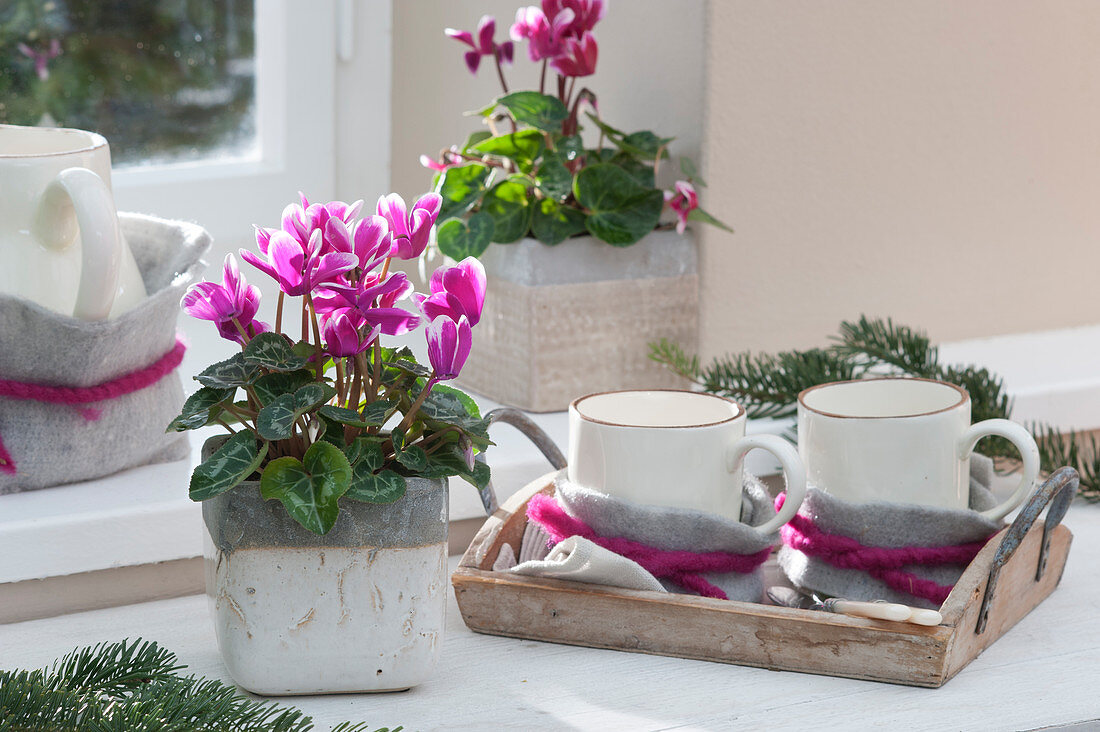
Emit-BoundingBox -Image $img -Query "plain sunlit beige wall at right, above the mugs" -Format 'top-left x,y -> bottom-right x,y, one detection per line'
699,0 -> 1100,356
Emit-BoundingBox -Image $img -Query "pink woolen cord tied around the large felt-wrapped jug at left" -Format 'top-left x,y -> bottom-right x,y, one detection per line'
0,337 -> 187,474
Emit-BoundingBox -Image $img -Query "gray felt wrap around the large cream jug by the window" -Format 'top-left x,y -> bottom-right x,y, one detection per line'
0,214 -> 210,494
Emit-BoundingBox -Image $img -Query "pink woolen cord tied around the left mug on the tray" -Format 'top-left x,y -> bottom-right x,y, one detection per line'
527,493 -> 771,600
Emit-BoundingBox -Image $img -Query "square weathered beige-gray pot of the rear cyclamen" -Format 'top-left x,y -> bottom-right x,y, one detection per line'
460,231 -> 699,412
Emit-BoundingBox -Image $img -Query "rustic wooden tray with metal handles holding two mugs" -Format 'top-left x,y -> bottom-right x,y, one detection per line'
451,417 -> 1078,687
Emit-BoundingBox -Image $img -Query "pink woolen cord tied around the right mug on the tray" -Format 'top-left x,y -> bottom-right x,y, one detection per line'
776,493 -> 993,605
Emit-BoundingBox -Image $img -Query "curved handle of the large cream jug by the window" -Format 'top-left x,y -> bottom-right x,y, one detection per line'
34,167 -> 122,320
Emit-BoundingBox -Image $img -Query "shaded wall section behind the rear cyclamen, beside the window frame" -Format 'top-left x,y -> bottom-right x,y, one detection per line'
392,0 -> 705,198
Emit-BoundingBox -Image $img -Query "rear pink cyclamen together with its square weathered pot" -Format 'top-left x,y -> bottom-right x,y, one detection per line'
421,0 -> 728,411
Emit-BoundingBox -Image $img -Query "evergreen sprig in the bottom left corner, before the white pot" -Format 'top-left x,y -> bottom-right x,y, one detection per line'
0,638 -> 402,732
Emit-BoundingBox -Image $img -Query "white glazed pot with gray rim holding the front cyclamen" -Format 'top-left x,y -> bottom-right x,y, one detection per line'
202,438 -> 448,695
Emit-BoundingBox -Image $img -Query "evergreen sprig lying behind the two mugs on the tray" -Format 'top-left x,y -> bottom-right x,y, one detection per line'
649,316 -> 1100,501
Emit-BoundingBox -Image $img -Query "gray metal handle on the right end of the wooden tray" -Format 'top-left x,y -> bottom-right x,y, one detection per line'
974,467 -> 1080,634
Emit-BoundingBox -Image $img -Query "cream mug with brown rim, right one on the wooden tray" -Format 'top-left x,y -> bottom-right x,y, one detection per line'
799,379 -> 1040,520
